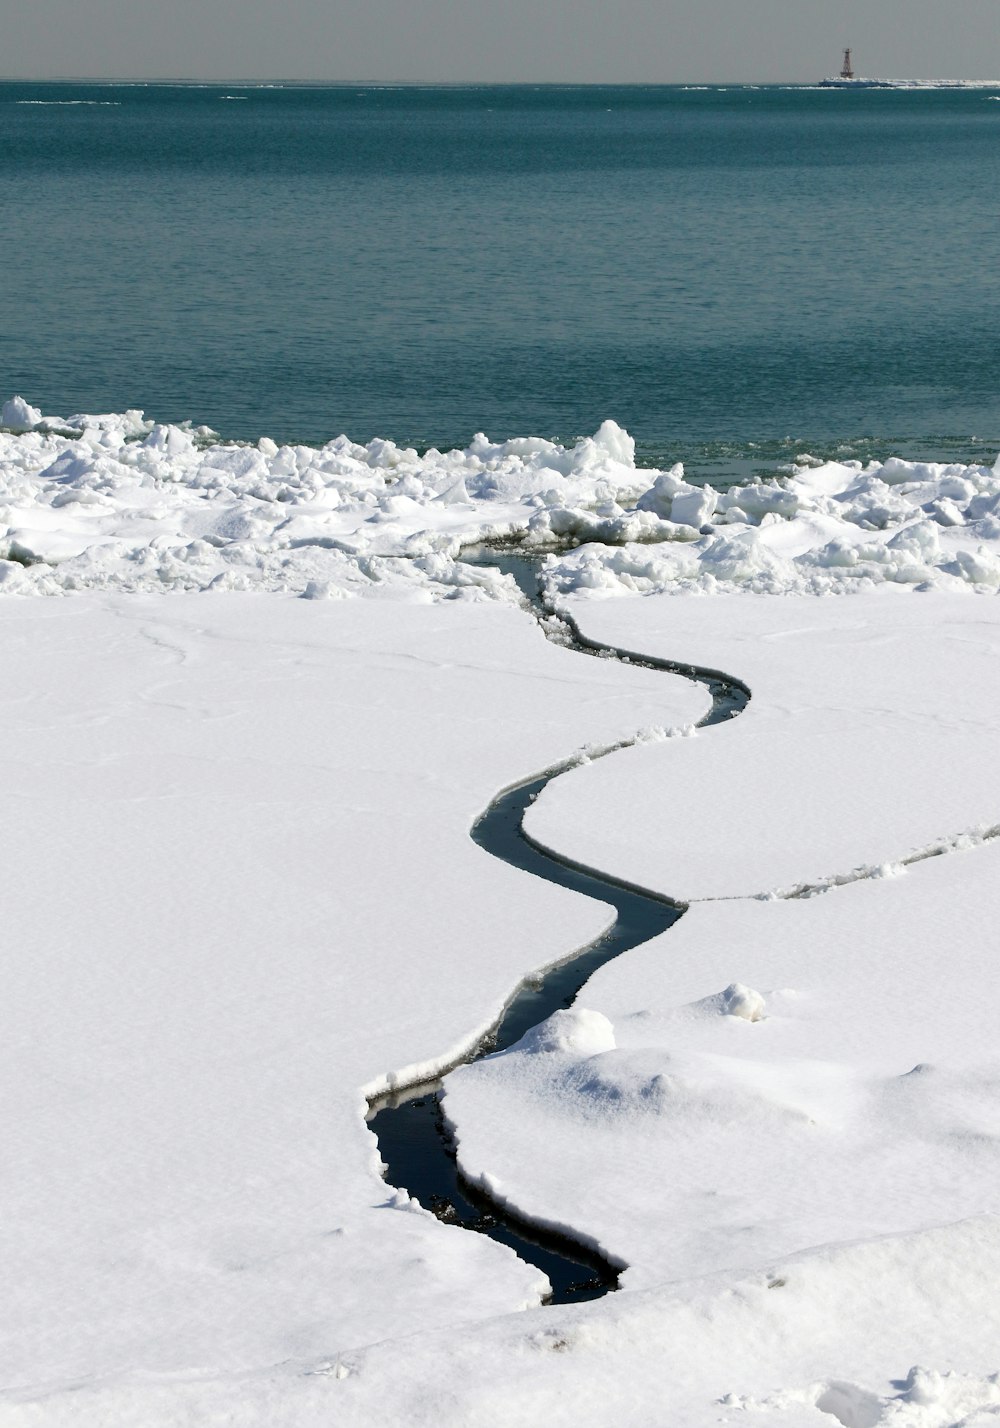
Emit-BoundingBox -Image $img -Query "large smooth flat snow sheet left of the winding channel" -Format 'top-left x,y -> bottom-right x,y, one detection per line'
0,595 -> 704,1389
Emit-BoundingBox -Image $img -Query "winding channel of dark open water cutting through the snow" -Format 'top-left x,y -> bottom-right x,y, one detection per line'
362,551 -> 750,1304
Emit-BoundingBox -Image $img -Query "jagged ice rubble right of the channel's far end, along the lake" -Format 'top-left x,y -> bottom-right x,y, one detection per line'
546,457 -> 1000,597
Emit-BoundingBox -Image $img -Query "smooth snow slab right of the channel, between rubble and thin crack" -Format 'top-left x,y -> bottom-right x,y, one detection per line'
526,591 -> 1000,891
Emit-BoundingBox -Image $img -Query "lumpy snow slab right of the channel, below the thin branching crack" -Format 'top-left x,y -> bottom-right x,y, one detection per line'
444,845 -> 1000,1289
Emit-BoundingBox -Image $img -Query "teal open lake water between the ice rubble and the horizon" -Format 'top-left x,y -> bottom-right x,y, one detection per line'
0,84 -> 1000,476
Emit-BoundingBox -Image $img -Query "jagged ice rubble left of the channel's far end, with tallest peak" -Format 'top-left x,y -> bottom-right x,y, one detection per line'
0,397 -> 648,600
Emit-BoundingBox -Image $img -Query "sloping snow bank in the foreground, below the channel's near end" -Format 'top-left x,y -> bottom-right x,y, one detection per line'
17,1217 -> 1000,1428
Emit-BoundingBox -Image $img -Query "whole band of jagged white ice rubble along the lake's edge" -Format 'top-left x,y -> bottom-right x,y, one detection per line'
0,397 -> 1000,600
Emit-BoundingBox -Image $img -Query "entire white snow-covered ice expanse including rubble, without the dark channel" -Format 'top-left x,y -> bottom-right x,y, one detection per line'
0,400 -> 1000,1428
